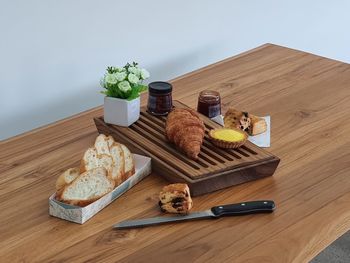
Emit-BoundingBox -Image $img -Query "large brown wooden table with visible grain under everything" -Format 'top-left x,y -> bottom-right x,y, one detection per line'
0,44 -> 350,263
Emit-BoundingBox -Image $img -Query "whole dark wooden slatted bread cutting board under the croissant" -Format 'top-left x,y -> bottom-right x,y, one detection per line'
94,101 -> 280,196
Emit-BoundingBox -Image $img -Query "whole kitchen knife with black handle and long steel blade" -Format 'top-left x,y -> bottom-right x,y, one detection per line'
113,200 -> 275,229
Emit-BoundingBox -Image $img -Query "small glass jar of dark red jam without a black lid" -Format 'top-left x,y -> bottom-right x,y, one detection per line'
197,90 -> 221,118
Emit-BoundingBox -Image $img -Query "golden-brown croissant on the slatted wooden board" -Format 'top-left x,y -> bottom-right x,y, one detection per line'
165,108 -> 205,160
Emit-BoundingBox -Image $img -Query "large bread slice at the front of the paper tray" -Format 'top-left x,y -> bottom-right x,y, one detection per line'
56,167 -> 115,206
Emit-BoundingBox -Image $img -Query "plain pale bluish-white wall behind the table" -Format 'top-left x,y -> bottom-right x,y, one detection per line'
0,0 -> 350,140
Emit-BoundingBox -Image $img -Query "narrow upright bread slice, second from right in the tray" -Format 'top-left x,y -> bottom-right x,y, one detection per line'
110,142 -> 125,186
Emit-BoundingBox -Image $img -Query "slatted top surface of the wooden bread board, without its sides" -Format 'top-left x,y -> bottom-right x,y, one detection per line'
97,101 -> 274,180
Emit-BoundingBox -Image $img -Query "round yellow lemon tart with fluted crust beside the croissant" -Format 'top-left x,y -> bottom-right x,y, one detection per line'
209,128 -> 248,149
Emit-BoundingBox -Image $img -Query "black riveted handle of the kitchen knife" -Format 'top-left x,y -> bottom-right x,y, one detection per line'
211,200 -> 276,217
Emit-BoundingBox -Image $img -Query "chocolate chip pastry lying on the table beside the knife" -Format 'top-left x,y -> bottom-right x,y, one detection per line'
159,184 -> 193,214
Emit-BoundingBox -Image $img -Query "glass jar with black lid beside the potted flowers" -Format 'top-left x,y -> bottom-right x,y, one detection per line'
147,81 -> 173,115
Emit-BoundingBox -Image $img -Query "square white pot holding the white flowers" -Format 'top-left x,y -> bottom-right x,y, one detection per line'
104,96 -> 140,127
